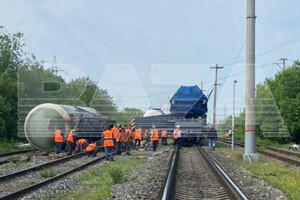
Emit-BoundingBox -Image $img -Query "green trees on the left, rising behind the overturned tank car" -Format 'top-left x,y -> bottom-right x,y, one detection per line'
0,28 -> 143,141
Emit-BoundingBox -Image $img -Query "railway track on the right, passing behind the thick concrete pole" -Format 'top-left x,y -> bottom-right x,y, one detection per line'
218,138 -> 300,167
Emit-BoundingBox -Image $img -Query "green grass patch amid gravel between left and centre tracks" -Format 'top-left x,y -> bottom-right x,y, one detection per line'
52,159 -> 144,200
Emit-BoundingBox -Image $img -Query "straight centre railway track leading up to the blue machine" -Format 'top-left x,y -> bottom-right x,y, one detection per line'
161,147 -> 247,200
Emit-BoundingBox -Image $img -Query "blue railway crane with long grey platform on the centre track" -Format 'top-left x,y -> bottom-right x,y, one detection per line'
134,85 -> 209,144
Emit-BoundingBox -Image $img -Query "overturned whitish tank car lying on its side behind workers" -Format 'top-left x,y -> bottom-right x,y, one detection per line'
24,103 -> 114,151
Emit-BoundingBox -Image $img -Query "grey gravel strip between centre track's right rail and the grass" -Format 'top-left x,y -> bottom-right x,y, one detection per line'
204,147 -> 289,200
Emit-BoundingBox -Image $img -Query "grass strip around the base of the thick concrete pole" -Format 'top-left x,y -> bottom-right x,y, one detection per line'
219,147 -> 300,200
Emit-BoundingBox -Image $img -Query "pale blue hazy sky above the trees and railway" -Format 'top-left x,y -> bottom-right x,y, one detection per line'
0,0 -> 300,121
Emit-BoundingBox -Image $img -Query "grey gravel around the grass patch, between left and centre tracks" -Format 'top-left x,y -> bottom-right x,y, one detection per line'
19,147 -> 172,200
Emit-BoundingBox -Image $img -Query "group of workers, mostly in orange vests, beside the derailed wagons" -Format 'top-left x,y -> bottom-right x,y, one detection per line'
54,125 -> 217,161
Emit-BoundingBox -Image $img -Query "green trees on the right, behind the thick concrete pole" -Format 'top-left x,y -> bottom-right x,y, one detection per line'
218,61 -> 300,143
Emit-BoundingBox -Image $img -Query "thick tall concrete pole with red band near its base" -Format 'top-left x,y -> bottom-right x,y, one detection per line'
243,0 -> 259,162
